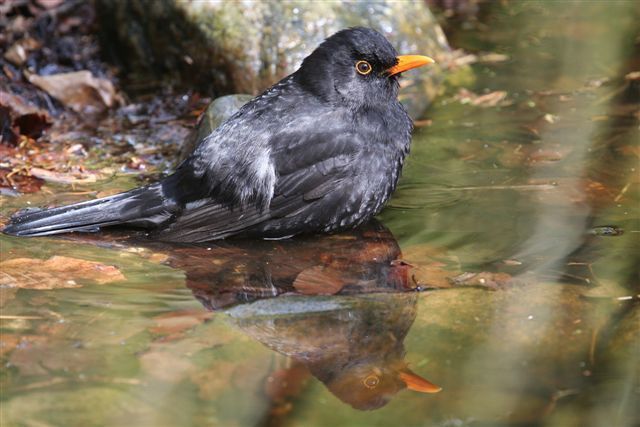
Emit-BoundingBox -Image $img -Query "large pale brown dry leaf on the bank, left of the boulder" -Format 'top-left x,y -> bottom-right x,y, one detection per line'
29,71 -> 121,113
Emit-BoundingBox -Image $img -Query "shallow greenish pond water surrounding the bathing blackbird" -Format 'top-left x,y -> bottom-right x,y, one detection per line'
0,1 -> 640,426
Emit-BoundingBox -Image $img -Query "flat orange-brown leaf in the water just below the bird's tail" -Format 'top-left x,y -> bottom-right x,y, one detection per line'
0,256 -> 125,290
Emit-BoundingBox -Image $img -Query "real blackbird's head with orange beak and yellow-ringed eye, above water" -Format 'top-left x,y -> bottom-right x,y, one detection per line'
296,27 -> 434,105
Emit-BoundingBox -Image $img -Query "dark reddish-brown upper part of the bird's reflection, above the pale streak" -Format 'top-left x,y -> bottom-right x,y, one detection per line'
180,220 -> 412,310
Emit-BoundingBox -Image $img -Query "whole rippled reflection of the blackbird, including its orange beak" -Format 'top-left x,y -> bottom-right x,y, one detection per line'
169,222 -> 440,409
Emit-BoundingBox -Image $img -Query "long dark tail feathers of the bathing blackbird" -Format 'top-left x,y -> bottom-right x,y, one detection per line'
2,184 -> 171,236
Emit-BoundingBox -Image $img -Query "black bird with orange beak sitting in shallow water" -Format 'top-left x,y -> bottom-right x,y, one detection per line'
3,27 -> 434,242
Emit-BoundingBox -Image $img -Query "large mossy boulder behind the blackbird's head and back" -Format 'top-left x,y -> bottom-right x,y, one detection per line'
96,0 -> 449,117
